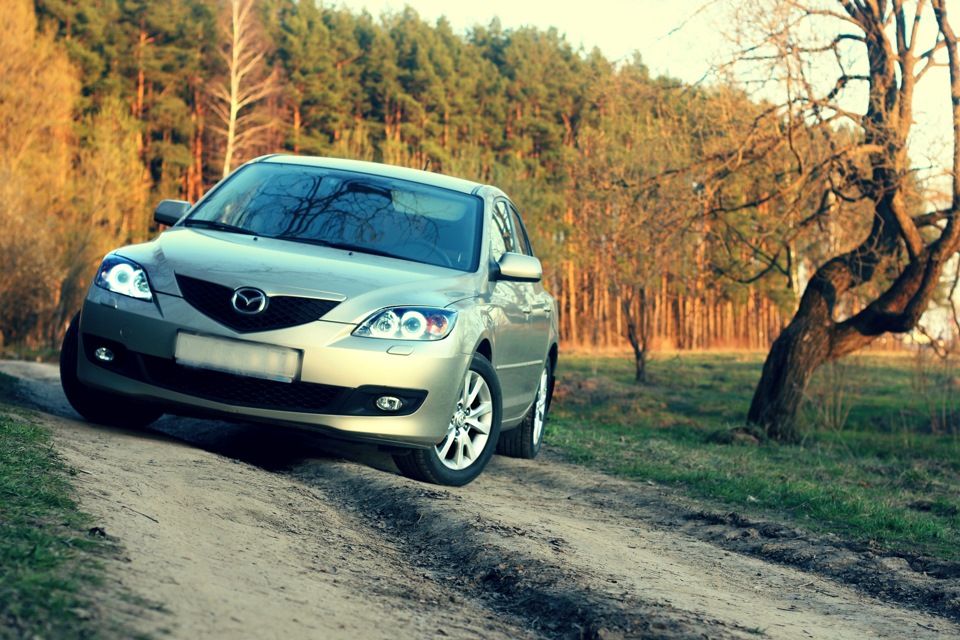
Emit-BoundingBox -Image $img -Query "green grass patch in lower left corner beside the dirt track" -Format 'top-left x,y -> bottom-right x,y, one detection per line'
0,374 -> 119,639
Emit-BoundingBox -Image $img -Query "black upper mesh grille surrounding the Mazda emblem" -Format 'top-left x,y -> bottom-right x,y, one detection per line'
177,274 -> 340,333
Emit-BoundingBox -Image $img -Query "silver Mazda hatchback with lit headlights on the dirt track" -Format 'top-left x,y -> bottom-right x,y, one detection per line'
60,155 -> 558,486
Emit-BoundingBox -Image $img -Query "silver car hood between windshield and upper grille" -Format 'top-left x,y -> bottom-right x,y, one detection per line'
116,227 -> 481,324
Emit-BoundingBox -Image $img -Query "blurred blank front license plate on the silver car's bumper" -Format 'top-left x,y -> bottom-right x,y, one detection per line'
174,332 -> 300,382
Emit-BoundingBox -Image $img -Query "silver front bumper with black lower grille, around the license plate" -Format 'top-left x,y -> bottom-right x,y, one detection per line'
77,287 -> 471,447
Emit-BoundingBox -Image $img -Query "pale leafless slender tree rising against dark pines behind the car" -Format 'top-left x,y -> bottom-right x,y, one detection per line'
210,0 -> 276,176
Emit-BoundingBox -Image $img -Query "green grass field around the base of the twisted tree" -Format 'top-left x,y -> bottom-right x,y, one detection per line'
548,354 -> 960,560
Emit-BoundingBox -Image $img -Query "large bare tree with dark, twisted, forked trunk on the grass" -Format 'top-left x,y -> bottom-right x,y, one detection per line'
712,0 -> 960,441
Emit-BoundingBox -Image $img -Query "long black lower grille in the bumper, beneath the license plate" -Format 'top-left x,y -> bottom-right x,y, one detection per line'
139,354 -> 352,413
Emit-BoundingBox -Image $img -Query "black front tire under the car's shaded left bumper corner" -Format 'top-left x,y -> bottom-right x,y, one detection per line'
60,313 -> 163,429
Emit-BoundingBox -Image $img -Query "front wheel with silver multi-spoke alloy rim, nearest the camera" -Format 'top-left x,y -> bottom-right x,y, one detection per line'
394,354 -> 503,487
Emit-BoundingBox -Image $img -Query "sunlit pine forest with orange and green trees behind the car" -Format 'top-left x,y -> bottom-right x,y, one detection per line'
0,0 -> 948,370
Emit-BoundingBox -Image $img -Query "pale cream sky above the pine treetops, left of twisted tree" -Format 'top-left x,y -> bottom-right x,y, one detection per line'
334,0 -> 722,82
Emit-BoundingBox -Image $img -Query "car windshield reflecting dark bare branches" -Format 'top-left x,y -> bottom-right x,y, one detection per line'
185,163 -> 483,271
